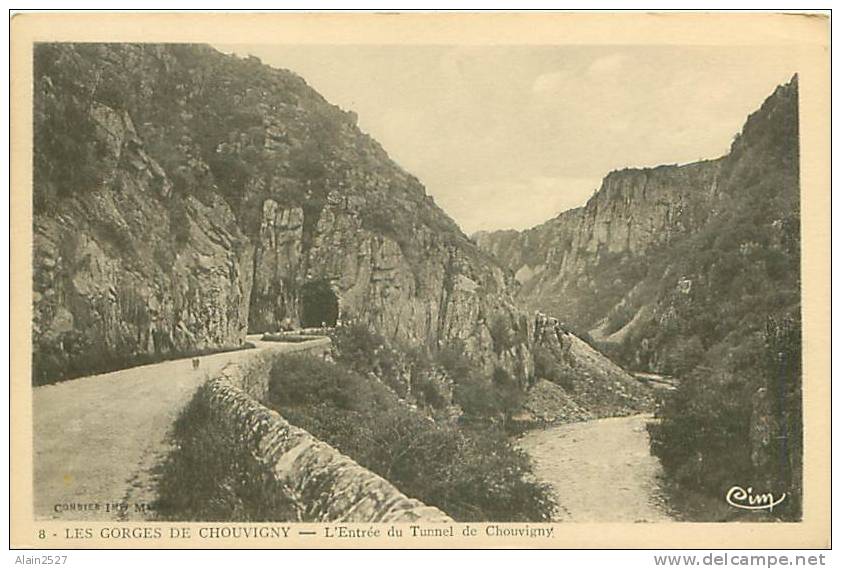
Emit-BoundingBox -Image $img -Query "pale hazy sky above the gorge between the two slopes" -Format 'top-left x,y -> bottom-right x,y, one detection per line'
215,45 -> 797,234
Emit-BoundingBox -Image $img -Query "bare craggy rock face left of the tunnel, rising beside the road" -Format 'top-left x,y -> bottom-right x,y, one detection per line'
33,97 -> 251,382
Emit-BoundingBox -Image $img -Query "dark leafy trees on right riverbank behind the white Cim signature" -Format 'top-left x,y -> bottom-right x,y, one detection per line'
649,318 -> 803,520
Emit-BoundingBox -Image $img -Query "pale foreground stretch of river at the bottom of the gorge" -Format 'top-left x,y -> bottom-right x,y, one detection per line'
519,415 -> 671,522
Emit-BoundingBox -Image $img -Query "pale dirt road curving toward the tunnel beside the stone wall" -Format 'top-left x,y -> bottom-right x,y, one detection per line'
33,338 -> 328,520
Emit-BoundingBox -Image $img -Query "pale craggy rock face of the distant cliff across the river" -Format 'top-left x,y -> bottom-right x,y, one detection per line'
474,159 -> 721,322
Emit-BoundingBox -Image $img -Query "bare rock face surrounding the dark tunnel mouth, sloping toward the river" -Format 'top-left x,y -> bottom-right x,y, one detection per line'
250,190 -> 531,378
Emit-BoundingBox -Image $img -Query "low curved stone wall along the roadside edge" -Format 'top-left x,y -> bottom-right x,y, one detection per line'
197,340 -> 451,523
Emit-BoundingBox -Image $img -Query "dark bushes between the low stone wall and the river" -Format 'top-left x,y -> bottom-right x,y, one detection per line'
268,356 -> 554,521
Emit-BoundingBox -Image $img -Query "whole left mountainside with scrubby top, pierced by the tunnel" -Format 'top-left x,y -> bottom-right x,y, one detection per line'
33,44 -> 531,383
